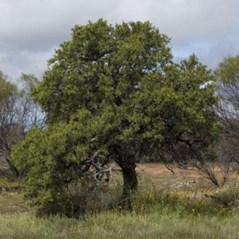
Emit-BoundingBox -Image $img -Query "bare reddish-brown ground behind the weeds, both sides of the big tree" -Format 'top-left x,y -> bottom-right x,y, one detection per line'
0,163 -> 233,214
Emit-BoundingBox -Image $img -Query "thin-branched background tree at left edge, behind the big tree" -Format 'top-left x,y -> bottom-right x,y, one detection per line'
0,72 -> 43,176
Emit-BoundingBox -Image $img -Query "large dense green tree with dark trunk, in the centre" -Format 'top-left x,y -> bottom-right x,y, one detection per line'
14,19 -> 218,213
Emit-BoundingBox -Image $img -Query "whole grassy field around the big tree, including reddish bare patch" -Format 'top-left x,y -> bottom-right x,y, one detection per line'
0,164 -> 239,239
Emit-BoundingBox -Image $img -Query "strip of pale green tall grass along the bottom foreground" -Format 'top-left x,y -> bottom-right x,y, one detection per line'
0,211 -> 239,239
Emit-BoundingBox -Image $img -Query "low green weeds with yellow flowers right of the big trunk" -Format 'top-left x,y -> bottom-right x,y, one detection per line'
132,185 -> 230,216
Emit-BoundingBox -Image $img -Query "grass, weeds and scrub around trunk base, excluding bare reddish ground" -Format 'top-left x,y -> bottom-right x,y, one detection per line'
0,165 -> 239,239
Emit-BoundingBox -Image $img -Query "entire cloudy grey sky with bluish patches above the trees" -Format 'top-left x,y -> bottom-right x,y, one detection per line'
0,0 -> 239,79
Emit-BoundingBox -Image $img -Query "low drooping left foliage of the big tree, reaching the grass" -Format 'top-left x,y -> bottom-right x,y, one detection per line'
13,120 -> 119,216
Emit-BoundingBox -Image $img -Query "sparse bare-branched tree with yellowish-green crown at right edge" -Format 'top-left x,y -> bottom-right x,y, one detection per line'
215,56 -> 239,162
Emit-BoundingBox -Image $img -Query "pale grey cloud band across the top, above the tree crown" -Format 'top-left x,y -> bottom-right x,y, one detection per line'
0,0 -> 239,45
